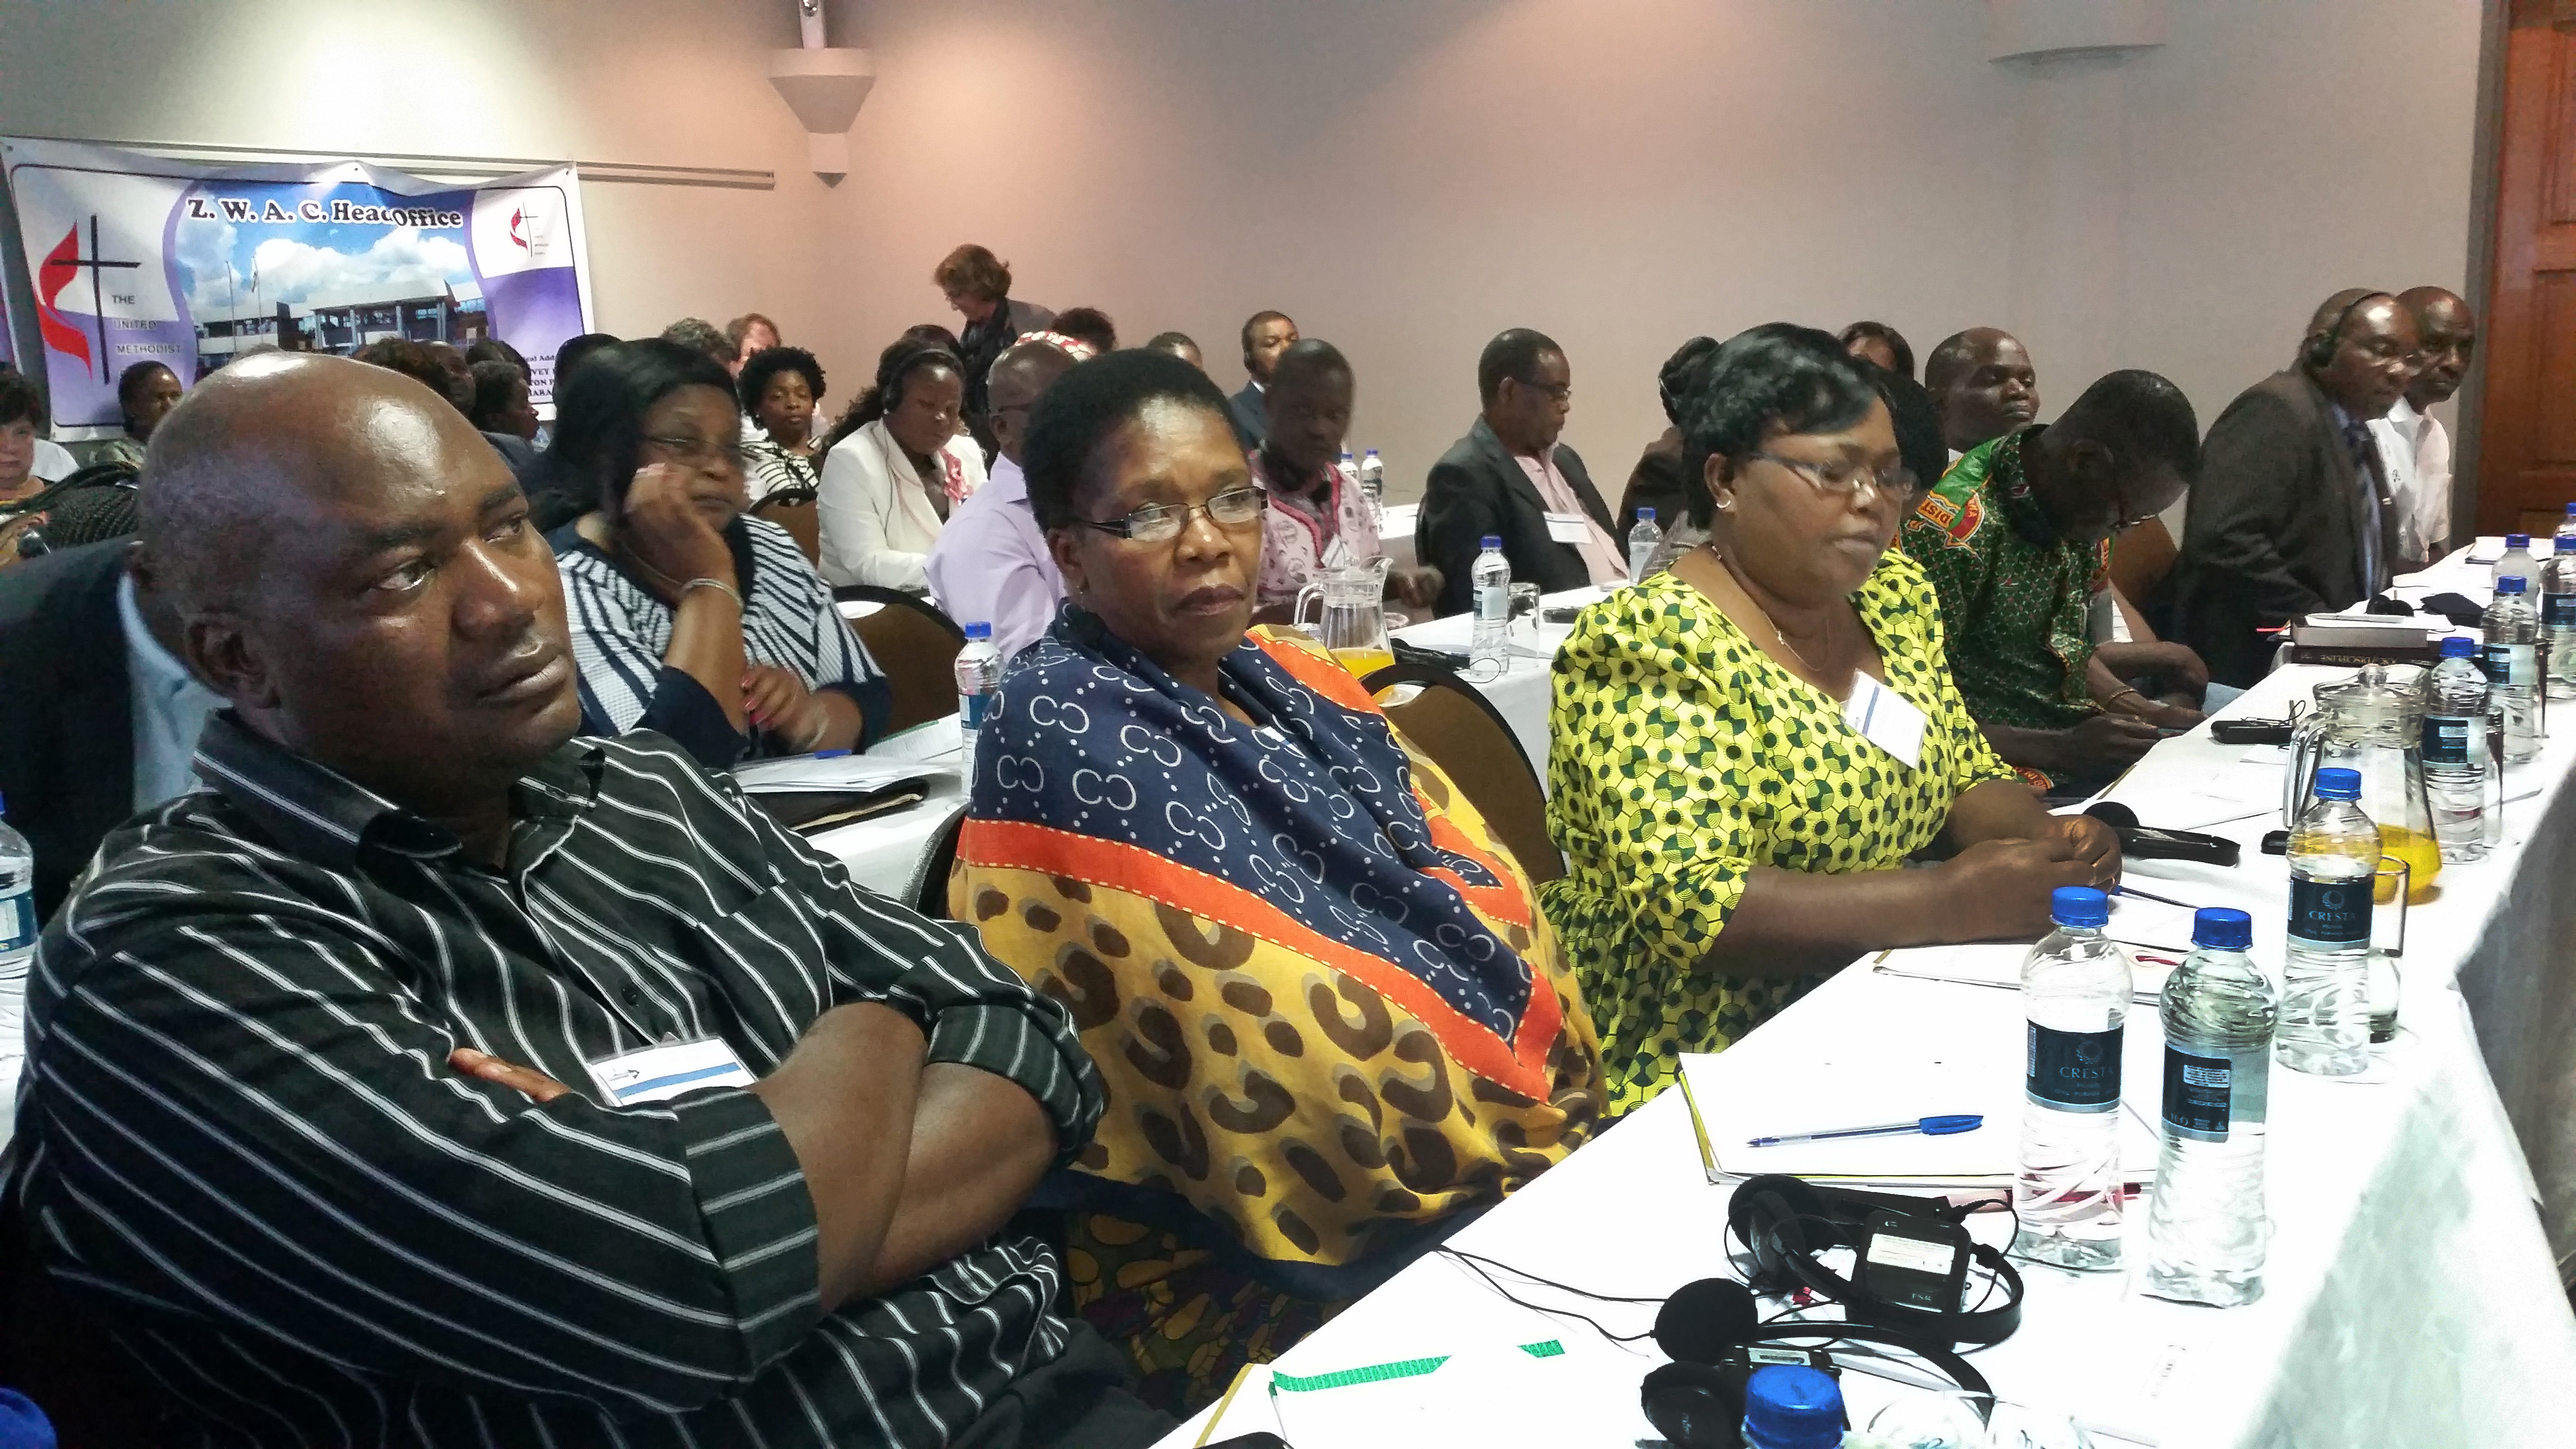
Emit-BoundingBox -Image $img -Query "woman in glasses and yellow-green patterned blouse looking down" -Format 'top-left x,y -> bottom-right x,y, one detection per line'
1546,325 -> 2120,1111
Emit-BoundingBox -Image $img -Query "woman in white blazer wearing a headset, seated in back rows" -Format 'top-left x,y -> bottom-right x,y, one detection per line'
819,340 -> 984,593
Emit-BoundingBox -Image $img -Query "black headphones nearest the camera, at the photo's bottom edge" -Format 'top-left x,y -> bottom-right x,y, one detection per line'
1638,1279 -> 1994,1449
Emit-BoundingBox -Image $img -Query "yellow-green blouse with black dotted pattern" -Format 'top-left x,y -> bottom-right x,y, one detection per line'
1541,549 -> 2012,1111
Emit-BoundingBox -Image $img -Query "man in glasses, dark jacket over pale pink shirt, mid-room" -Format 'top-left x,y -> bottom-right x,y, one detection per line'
1414,327 -> 1628,613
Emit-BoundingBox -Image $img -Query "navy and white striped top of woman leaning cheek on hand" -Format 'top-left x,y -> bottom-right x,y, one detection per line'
546,518 -> 894,771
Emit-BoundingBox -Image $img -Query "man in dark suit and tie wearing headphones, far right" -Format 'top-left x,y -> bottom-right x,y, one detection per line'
2174,289 -> 2416,689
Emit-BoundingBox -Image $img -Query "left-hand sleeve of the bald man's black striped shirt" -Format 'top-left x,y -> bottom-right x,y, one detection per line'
35,915 -> 822,1416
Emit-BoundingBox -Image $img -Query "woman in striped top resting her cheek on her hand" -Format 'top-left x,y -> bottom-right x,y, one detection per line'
541,340 -> 891,768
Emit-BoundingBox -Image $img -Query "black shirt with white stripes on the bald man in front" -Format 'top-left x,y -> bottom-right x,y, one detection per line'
16,711 -> 1100,1449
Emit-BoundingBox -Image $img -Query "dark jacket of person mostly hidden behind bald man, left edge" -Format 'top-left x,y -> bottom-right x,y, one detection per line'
0,539 -> 161,920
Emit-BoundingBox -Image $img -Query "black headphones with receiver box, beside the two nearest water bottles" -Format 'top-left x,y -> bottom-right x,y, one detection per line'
1726,1175 -> 2022,1346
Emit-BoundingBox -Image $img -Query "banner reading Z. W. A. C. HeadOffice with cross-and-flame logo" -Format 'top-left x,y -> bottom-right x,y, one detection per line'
0,137 -> 590,438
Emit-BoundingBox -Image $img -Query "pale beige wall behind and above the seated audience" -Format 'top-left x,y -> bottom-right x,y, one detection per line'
0,0 -> 2480,495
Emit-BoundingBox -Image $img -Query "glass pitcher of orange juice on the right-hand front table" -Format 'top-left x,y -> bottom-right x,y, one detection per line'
2280,665 -> 2442,902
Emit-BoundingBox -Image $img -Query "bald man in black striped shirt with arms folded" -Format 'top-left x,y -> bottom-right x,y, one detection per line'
18,356 -> 1167,1449
